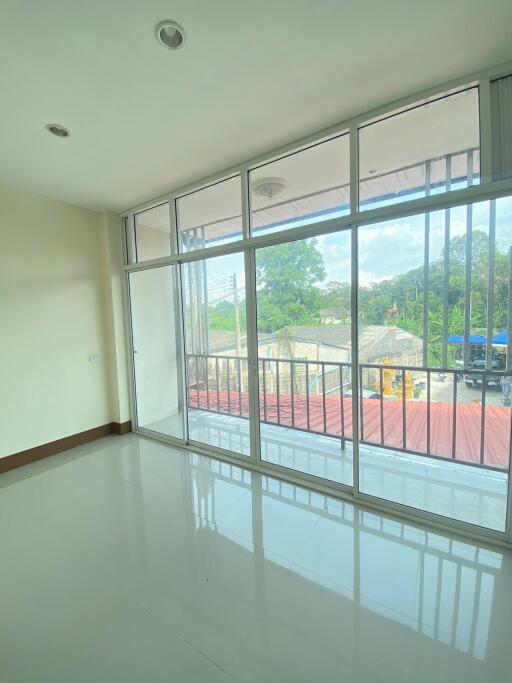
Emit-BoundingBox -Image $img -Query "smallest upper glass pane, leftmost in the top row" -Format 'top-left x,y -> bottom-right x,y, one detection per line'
135,202 -> 171,263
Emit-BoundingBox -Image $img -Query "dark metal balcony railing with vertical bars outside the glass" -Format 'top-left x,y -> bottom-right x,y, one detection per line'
186,354 -> 511,471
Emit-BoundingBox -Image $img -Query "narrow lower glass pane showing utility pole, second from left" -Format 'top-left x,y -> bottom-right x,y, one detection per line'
182,254 -> 250,455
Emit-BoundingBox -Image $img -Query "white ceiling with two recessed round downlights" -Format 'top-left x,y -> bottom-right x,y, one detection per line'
0,0 -> 512,211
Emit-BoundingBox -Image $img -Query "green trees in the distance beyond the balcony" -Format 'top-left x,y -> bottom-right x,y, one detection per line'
209,230 -> 509,352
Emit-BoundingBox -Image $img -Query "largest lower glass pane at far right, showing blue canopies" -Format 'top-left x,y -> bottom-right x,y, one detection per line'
358,198 -> 512,531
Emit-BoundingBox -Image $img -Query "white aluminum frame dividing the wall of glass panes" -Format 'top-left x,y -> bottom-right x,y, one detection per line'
121,63 -> 512,547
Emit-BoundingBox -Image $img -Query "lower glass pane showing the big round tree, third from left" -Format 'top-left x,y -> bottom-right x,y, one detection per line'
256,231 -> 352,485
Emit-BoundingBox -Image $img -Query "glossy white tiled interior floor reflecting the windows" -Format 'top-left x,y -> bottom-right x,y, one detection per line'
0,435 -> 512,683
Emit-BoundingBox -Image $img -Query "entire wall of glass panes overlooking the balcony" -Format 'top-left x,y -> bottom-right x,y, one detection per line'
127,76 -> 512,544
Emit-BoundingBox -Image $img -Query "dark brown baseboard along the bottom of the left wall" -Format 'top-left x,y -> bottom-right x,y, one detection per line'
0,420 -> 132,474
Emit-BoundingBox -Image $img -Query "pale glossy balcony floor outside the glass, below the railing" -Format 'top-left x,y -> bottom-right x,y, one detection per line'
179,409 -> 508,530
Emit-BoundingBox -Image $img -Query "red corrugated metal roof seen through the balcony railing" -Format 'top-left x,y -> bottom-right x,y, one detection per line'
189,389 -> 511,470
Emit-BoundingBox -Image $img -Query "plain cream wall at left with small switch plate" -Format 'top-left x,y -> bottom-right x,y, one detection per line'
0,185 -> 120,457
